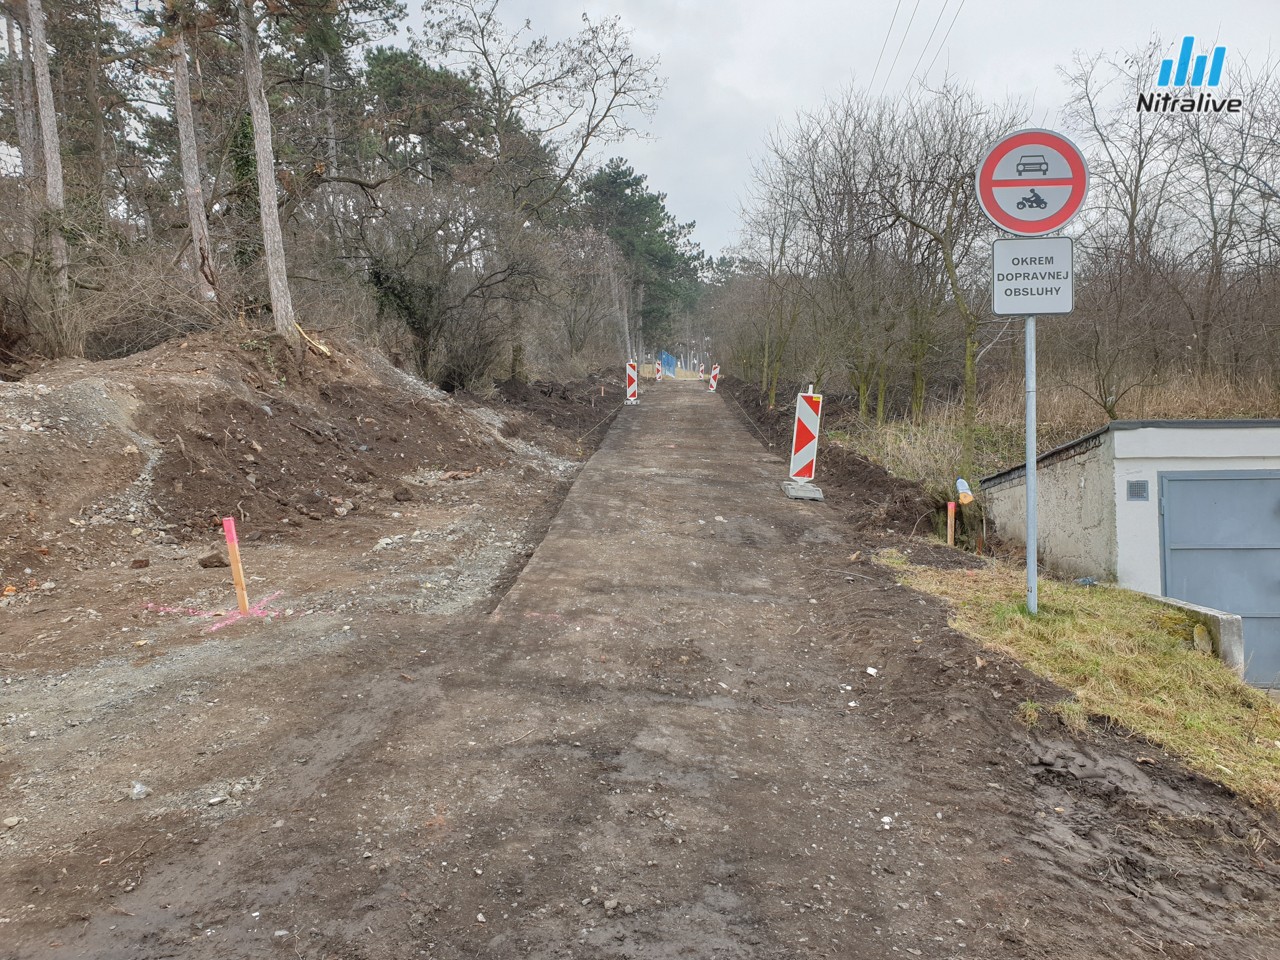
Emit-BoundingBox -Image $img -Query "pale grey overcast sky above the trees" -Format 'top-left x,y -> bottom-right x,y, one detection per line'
410,0 -> 1280,253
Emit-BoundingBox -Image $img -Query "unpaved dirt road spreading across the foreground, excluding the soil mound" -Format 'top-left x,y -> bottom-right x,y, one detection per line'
0,371 -> 1280,960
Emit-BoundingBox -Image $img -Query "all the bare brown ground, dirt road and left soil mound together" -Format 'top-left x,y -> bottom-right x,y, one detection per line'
0,348 -> 1280,960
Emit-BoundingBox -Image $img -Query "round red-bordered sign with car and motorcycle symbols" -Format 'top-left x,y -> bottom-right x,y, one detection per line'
977,129 -> 1089,237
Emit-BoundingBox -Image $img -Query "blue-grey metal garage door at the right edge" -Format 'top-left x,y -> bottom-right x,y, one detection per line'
1160,470 -> 1280,687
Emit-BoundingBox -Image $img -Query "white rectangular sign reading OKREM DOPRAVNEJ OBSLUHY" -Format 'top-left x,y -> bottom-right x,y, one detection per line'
991,237 -> 1075,316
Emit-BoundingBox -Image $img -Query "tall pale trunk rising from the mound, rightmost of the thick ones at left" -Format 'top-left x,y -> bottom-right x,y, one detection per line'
238,0 -> 302,351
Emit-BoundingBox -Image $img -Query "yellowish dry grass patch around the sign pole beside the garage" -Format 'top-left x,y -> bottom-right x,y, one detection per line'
890,561 -> 1280,809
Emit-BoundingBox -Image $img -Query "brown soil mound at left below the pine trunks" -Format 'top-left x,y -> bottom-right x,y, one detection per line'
0,334 -> 620,584
